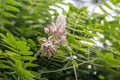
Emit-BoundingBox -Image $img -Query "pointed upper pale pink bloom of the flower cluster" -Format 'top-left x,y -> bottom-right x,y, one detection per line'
44,14 -> 67,46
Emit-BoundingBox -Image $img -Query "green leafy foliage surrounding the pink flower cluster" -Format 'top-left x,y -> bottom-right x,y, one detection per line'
0,0 -> 120,80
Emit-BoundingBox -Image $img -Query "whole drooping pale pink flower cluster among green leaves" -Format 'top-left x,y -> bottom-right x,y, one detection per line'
41,14 -> 67,58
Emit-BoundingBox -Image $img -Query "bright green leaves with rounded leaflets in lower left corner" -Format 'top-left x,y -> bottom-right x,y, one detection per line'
0,33 -> 37,80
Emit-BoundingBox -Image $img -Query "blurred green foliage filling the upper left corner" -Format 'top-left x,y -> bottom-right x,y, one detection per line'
0,0 -> 60,37
